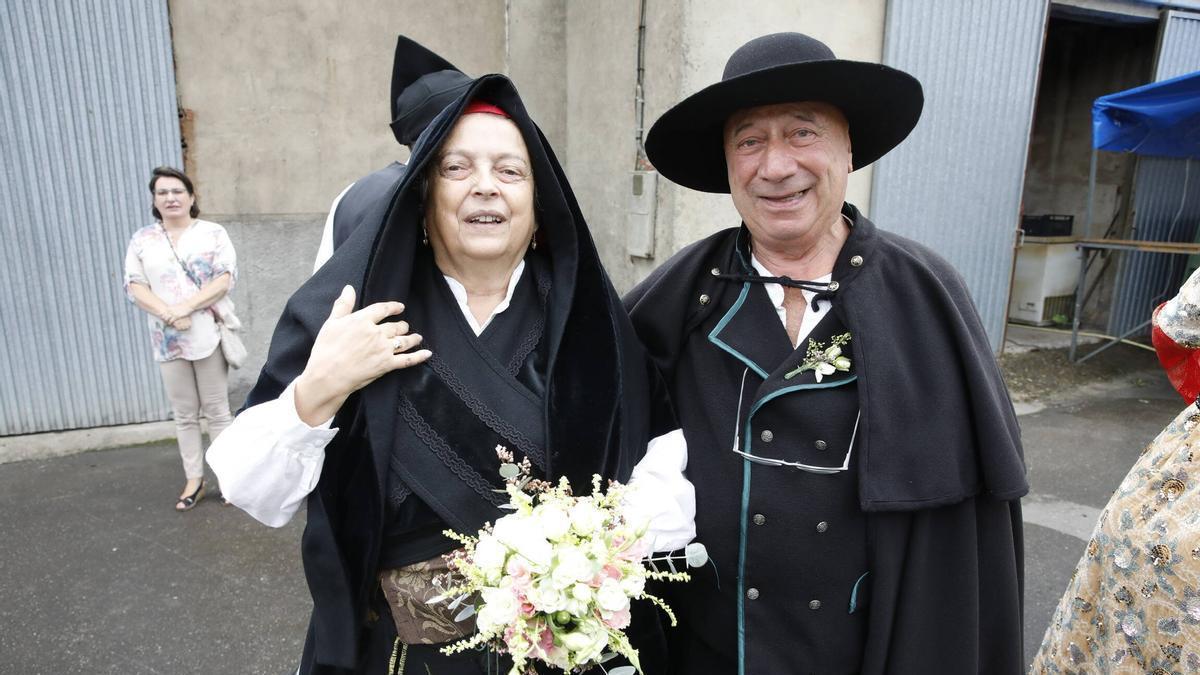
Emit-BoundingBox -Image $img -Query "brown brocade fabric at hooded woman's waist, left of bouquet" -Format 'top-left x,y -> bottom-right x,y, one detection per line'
379,556 -> 475,645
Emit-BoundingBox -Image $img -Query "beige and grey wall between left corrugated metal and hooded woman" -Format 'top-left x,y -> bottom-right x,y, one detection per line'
169,0 -> 508,405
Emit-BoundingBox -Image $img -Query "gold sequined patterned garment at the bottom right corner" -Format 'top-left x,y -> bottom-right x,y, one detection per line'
1030,406 -> 1200,675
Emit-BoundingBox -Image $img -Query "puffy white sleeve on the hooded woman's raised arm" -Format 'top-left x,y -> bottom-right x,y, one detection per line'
206,383 -> 337,527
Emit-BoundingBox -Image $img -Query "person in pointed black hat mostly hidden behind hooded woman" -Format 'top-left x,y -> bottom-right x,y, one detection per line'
313,35 -> 472,271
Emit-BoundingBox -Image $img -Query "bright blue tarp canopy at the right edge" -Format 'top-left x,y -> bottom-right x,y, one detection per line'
1092,71 -> 1200,157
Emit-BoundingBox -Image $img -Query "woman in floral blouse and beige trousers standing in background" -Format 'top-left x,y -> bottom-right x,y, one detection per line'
125,167 -> 238,510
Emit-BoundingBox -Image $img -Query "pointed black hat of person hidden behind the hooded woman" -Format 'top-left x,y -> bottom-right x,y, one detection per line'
391,35 -> 474,147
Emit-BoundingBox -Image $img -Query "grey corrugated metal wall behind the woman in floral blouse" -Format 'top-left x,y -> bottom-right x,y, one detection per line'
0,0 -> 181,436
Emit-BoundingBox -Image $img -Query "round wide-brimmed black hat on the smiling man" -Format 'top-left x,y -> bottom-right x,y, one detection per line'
646,32 -> 925,192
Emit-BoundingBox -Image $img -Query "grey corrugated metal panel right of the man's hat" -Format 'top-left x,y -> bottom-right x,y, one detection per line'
871,0 -> 1048,350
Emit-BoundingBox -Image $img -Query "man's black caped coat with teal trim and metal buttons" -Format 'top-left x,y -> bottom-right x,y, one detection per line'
625,204 -> 1027,675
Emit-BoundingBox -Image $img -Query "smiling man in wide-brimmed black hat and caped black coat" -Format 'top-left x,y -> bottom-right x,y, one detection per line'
625,34 -> 1027,675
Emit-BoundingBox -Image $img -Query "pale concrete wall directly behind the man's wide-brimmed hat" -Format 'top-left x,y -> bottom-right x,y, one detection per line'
566,0 -> 886,291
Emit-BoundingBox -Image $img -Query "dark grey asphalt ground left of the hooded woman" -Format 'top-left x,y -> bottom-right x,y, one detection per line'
0,444 -> 311,675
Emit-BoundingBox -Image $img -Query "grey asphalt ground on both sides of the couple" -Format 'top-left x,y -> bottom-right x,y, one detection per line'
0,341 -> 1182,675
